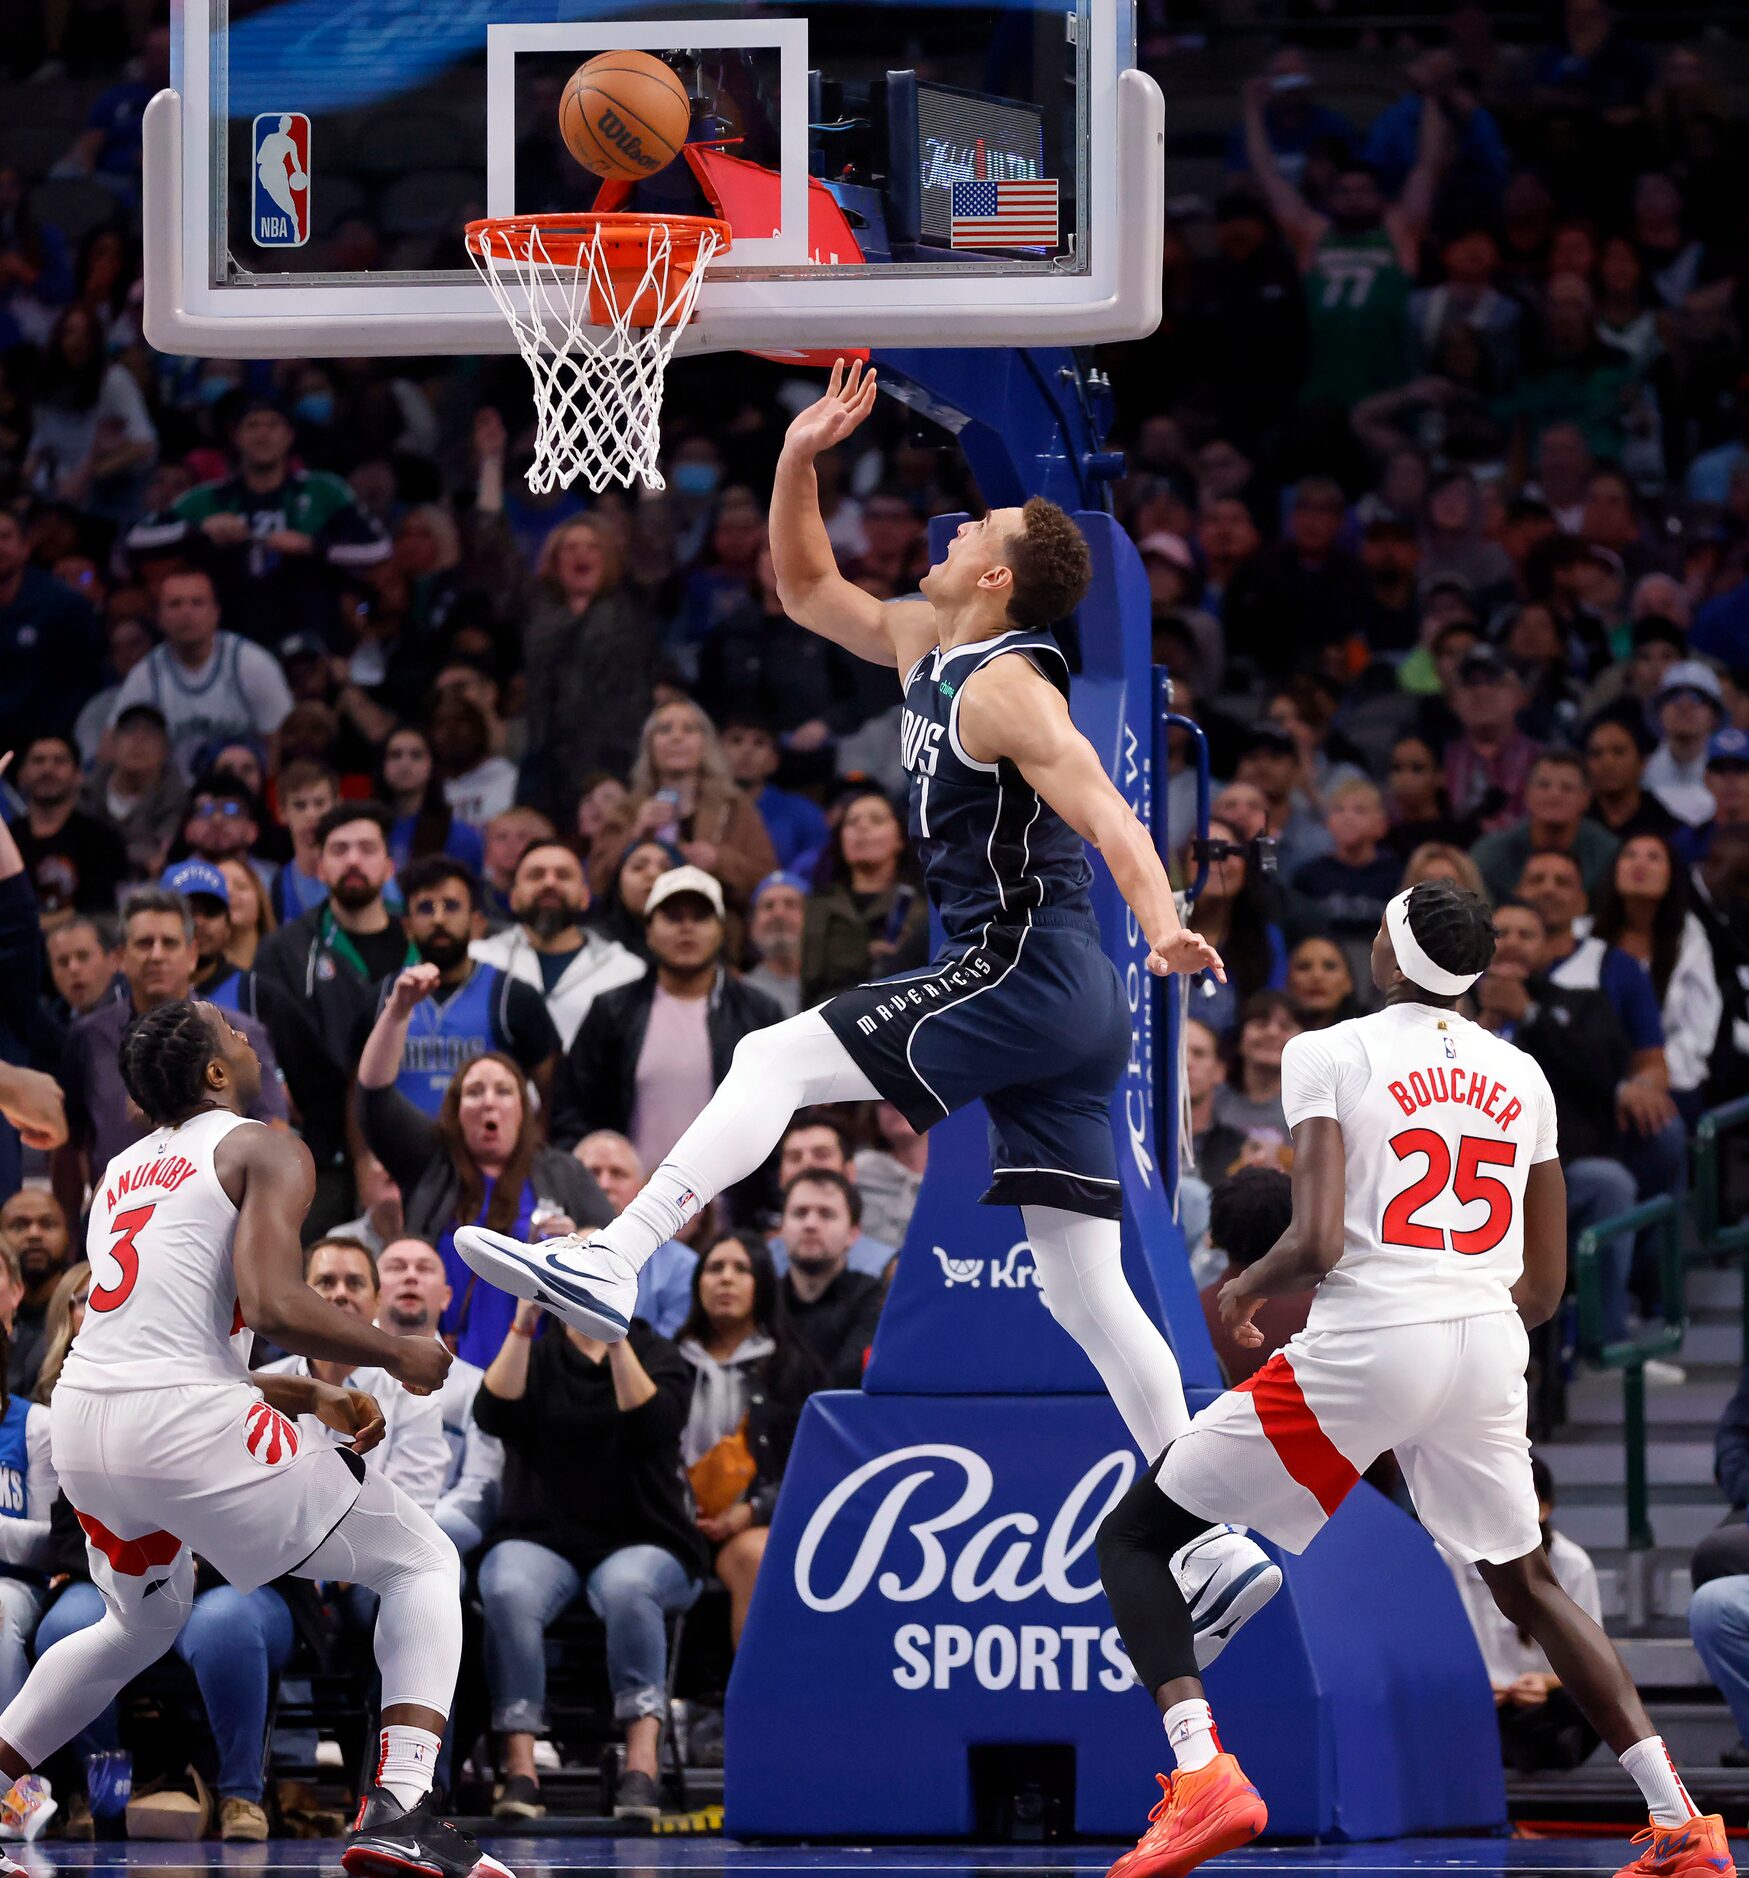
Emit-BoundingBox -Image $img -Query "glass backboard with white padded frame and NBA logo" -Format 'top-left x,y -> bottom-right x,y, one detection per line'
145,0 -> 1163,355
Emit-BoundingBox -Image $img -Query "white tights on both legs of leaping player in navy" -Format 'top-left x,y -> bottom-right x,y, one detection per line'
596,1010 -> 1191,1459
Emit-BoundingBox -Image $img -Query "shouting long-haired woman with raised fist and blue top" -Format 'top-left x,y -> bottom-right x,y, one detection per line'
357,963 -> 612,1367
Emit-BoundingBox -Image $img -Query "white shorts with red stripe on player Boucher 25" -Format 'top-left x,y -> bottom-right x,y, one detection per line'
1159,1311 -> 1540,1564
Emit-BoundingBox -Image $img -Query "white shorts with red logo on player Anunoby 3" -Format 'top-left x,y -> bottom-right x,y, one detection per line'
49,1382 -> 359,1591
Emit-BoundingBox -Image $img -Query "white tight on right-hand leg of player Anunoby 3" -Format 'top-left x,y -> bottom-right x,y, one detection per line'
298,1472 -> 462,1715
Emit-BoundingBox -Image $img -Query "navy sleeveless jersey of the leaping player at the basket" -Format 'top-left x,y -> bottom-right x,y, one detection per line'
900,631 -> 1093,939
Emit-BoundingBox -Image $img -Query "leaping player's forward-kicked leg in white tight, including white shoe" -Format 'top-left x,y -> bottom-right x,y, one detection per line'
455,1010 -> 879,1343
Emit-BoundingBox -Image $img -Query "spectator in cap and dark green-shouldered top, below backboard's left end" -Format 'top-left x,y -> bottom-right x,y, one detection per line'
128,385 -> 391,646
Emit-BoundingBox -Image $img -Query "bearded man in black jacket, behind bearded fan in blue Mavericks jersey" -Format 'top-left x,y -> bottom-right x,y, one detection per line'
255,802 -> 419,1234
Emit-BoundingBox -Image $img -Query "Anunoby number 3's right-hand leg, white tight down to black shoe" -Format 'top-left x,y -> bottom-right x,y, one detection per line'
295,1472 -> 503,1878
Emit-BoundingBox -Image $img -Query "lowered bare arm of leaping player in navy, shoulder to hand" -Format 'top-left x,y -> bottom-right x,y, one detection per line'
960,654 -> 1227,984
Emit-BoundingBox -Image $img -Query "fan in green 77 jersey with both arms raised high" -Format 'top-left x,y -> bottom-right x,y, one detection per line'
1244,77 -> 1452,411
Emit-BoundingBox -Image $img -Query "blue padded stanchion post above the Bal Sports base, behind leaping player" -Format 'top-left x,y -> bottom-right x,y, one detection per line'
864,511 -> 1219,1395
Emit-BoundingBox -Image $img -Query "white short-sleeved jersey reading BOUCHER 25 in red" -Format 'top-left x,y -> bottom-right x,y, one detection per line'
1281,1005 -> 1556,1330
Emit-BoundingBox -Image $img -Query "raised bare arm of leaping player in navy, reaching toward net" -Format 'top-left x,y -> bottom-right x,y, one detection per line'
770,359 -> 937,672
